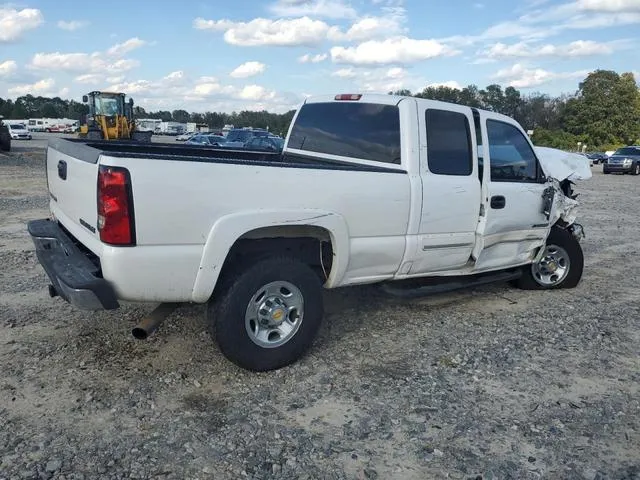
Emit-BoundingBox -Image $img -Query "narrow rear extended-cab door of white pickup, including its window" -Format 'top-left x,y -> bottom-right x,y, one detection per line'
408,100 -> 481,275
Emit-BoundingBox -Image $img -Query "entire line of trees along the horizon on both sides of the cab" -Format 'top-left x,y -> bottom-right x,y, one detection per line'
0,70 -> 640,150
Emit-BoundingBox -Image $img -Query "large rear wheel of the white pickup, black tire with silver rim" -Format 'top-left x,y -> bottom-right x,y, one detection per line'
206,257 -> 324,371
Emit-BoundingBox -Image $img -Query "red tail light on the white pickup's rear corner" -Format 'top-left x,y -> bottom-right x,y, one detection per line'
98,165 -> 136,246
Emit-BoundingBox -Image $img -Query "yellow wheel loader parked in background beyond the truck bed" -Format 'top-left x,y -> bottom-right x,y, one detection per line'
78,91 -> 152,142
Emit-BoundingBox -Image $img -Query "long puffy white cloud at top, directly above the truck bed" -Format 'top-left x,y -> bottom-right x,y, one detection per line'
193,16 -> 329,47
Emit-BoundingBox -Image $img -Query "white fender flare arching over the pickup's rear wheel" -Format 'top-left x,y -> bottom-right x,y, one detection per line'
191,209 -> 349,303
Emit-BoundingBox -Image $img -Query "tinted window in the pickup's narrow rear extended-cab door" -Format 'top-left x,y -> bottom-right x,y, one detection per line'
425,109 -> 473,176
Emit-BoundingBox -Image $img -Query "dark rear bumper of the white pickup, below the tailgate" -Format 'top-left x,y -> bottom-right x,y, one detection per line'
27,219 -> 120,310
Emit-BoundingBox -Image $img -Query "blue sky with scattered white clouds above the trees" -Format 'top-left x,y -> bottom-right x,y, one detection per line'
0,0 -> 640,112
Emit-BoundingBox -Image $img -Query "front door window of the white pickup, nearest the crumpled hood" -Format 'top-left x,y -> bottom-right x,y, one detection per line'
487,120 -> 538,182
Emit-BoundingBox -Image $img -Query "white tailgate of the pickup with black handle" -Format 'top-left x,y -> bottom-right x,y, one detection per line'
46,138 -> 101,243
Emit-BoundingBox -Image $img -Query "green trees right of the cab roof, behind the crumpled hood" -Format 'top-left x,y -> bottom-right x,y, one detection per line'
389,70 -> 640,151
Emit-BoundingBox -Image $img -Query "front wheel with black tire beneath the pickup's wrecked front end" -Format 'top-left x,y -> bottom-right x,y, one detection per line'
515,227 -> 584,290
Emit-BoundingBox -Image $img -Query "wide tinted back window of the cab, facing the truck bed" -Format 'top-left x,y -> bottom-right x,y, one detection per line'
288,102 -> 400,164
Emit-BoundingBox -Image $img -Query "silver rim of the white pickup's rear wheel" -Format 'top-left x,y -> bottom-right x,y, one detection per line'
244,281 -> 304,348
